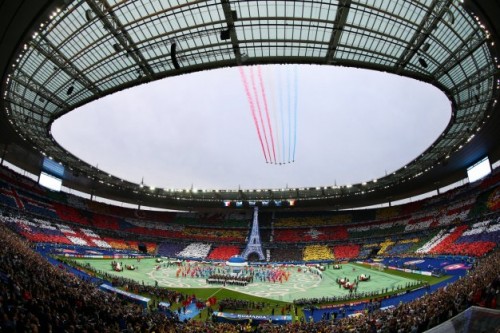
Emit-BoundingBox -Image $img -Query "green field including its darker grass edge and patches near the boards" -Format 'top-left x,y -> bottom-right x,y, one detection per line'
65,258 -> 449,321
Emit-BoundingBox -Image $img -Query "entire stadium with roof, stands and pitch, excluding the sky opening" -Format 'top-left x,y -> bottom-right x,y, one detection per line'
0,0 -> 500,332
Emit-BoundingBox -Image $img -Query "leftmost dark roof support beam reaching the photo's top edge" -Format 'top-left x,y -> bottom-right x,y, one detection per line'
86,0 -> 154,80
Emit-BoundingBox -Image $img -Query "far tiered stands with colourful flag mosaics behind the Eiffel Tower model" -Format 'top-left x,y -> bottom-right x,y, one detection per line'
0,161 -> 500,261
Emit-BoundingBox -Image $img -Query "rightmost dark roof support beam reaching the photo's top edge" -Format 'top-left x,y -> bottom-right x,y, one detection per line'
396,0 -> 452,74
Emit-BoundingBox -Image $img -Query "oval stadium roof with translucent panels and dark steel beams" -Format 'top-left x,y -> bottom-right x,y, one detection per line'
0,0 -> 500,209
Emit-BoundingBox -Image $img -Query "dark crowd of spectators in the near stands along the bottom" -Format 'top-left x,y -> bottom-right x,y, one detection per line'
0,217 -> 500,333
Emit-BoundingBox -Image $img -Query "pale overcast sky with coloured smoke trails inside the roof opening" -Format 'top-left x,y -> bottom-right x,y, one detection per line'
52,65 -> 451,189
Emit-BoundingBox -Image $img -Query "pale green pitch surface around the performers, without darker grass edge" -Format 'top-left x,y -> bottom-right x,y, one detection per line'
72,259 -> 432,302
